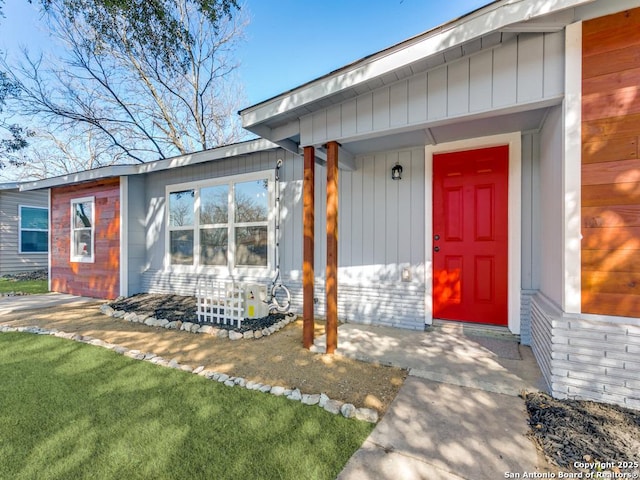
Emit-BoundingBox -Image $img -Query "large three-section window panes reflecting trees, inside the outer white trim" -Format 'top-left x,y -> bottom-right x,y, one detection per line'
167,172 -> 273,268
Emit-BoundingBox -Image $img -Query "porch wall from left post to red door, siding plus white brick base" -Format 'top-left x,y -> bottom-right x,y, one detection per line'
308,146 -> 425,329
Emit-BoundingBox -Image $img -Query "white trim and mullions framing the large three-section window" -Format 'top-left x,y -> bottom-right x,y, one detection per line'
164,170 -> 276,278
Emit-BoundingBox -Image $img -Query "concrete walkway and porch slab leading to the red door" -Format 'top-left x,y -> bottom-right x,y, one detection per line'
315,323 -> 543,480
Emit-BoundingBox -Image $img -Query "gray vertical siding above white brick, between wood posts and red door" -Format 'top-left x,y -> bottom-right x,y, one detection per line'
314,147 -> 425,287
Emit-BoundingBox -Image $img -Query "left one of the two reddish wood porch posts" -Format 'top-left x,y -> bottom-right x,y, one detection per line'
302,147 -> 316,349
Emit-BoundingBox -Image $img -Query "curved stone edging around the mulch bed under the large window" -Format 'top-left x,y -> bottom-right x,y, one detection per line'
100,303 -> 295,340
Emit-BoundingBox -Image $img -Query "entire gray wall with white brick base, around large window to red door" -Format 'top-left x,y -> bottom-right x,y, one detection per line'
141,146 -> 425,328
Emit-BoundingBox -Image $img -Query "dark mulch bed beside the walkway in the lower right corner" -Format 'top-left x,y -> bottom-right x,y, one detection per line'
525,392 -> 640,472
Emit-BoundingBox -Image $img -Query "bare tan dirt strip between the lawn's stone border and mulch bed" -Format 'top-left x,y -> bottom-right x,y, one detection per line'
1,302 -> 407,414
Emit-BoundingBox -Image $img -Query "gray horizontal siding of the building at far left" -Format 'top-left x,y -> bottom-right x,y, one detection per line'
0,188 -> 49,275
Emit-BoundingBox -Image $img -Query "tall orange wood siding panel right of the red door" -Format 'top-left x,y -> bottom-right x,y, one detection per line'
582,8 -> 640,317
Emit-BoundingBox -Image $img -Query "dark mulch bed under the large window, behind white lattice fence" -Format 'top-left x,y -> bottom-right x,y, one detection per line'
109,293 -> 285,333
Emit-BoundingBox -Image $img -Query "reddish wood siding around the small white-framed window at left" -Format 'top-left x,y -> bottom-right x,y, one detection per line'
51,178 -> 120,299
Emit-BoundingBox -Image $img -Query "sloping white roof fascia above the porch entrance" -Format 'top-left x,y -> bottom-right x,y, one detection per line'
240,0 -> 596,131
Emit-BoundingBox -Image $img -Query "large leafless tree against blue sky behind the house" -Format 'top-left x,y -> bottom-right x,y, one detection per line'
2,0 -> 244,169
